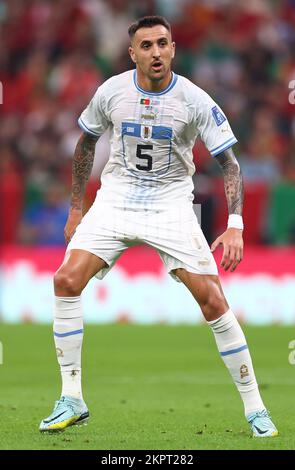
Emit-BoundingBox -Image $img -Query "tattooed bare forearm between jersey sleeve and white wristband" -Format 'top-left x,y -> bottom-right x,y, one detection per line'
215,148 -> 244,215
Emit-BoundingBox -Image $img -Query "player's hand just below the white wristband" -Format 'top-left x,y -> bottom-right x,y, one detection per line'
211,228 -> 244,272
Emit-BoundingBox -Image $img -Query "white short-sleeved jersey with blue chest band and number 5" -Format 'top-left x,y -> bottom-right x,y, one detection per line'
78,70 -> 237,210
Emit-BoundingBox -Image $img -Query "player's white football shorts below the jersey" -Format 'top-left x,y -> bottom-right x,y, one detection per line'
67,201 -> 218,281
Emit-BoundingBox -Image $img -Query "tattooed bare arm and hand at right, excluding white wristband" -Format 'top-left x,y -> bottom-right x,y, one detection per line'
211,148 -> 244,271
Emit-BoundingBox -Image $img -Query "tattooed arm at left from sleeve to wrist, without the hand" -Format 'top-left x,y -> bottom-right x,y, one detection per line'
71,133 -> 98,209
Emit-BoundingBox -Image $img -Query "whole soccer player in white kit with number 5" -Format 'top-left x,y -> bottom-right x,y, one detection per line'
40,16 -> 278,437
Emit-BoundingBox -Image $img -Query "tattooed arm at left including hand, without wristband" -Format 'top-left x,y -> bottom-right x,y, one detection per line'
64,133 -> 97,242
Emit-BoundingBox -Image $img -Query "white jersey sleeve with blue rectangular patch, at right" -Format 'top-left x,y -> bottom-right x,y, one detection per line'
196,91 -> 237,157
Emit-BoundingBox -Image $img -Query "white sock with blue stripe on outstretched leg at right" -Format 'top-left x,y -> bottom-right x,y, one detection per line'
208,310 -> 265,416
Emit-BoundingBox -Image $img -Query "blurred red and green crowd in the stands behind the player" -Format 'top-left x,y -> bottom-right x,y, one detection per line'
0,0 -> 295,245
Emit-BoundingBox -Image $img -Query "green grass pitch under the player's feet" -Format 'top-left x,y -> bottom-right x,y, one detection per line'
0,324 -> 295,450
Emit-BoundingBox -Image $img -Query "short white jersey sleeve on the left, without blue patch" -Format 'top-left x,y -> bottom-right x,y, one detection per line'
78,84 -> 109,137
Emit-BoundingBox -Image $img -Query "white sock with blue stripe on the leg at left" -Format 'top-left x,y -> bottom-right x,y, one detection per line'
53,296 -> 83,399
